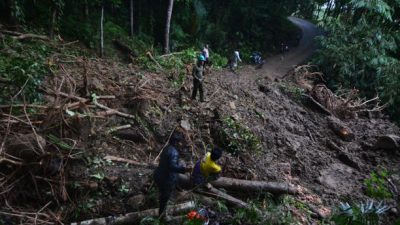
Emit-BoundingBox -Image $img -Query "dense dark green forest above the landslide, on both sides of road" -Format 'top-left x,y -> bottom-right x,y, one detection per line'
0,0 -> 400,119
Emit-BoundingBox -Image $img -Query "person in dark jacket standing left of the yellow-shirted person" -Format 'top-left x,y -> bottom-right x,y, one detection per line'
154,131 -> 190,218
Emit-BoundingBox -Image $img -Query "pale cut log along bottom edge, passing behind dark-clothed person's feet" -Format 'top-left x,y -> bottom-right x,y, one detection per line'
71,201 -> 196,225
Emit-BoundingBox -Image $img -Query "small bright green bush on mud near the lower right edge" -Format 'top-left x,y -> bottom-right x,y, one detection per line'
364,170 -> 393,199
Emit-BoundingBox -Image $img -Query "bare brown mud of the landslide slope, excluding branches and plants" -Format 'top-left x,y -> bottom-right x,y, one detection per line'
1,18 -> 400,225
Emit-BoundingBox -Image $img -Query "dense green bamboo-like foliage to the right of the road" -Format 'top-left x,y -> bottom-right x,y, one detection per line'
313,0 -> 400,121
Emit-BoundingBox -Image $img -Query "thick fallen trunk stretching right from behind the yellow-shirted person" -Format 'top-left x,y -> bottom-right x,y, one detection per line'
179,174 -> 298,194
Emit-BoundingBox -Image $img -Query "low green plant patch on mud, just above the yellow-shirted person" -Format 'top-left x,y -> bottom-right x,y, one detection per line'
220,117 -> 262,155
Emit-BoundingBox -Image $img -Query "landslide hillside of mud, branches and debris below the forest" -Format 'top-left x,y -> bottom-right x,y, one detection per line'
0,20 -> 400,224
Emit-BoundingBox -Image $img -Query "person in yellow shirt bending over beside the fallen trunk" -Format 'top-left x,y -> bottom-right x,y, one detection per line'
192,148 -> 222,186
